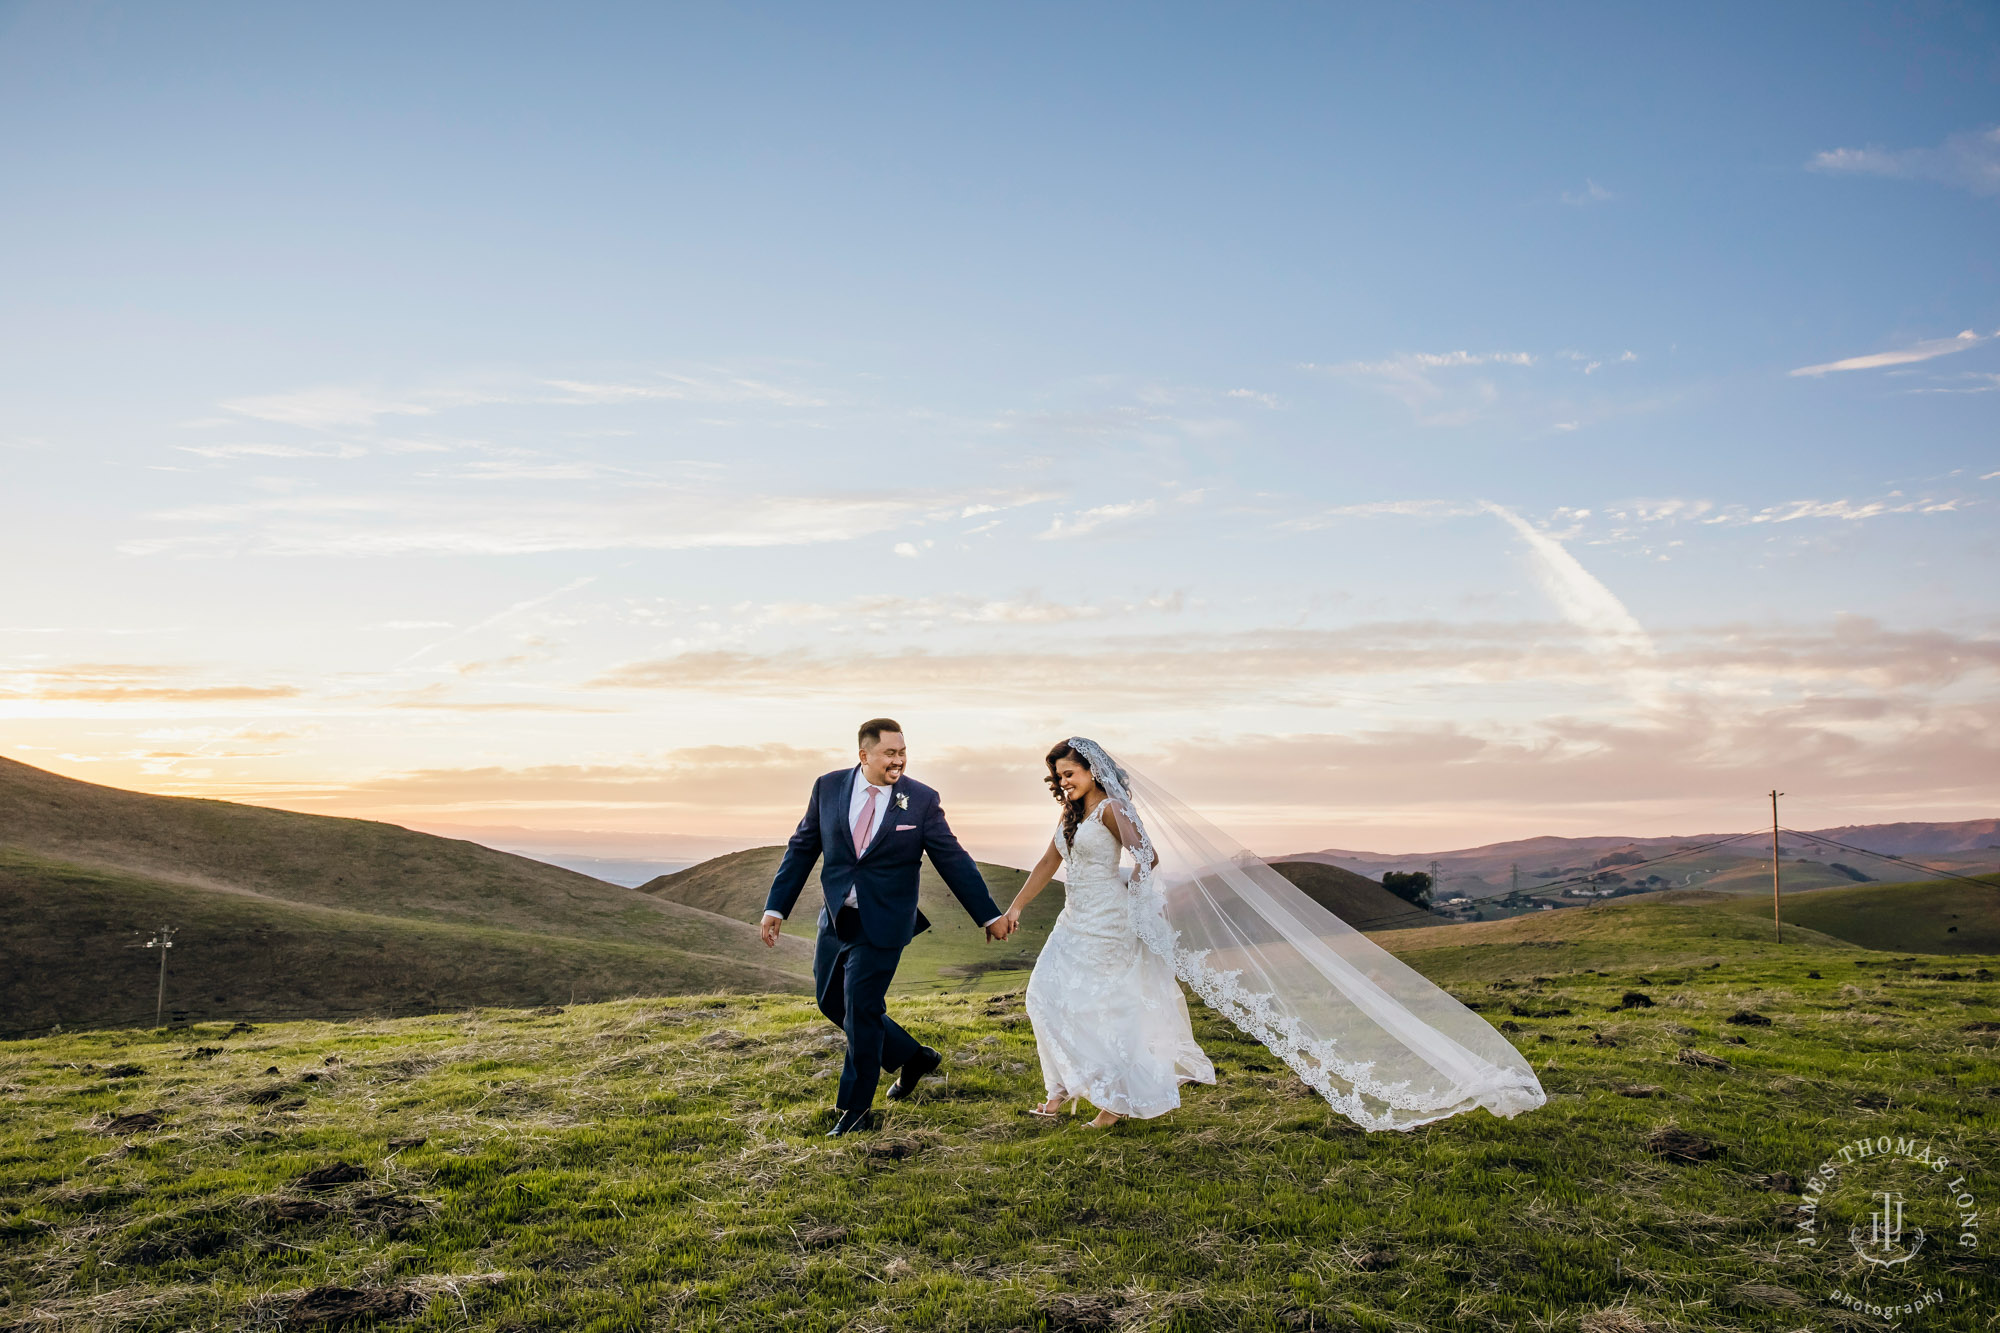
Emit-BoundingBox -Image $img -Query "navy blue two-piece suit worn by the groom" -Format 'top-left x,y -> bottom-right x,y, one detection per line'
764,769 -> 1000,1111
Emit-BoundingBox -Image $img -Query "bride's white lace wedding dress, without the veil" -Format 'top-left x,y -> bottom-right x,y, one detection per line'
1028,799 -> 1216,1121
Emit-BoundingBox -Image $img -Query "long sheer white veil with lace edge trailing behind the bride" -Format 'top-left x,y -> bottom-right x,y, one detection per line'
1070,737 -> 1548,1129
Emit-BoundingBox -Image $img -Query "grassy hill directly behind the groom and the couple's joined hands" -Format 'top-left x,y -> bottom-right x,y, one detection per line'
640,847 -> 1062,991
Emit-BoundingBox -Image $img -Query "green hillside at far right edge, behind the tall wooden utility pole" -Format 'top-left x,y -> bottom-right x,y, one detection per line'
1718,875 -> 2000,955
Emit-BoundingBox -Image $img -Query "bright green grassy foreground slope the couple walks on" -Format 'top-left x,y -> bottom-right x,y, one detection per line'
0,905 -> 2000,1333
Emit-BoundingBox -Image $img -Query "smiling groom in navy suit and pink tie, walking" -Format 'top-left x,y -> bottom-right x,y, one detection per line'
762,717 -> 1012,1139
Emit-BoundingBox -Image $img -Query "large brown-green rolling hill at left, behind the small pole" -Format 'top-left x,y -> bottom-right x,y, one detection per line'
0,759 -> 810,1033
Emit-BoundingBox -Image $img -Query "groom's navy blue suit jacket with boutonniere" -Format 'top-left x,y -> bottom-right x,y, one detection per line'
764,769 -> 1000,949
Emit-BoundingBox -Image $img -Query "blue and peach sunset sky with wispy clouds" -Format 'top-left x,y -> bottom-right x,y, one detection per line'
0,2 -> 2000,865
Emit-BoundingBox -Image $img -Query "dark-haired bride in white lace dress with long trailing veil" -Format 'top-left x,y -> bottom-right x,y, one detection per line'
1006,737 -> 1548,1129
